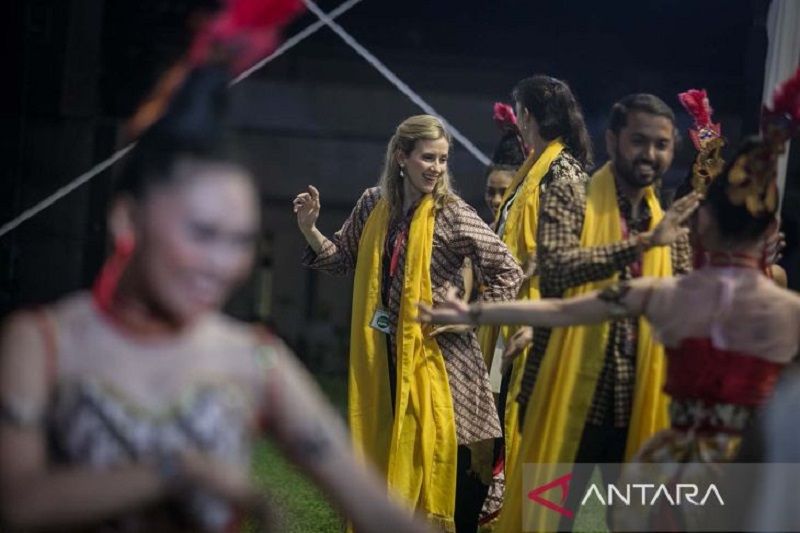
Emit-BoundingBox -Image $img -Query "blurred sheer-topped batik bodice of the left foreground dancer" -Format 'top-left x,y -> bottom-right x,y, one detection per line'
41,293 -> 283,531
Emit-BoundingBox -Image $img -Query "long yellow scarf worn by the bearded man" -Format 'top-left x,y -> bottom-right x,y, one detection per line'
498,164 -> 672,533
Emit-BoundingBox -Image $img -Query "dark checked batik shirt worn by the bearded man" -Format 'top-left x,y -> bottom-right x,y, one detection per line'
517,182 -> 691,427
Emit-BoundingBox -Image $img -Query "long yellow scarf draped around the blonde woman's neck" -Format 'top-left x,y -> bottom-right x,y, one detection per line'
349,195 -> 457,531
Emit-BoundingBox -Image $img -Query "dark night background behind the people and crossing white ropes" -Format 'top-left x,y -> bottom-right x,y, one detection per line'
0,0 -> 800,372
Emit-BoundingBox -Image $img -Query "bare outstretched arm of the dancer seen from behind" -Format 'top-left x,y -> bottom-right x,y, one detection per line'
419,278 -> 655,328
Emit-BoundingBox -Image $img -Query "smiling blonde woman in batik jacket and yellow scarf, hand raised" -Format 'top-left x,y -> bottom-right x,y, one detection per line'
294,115 -> 522,531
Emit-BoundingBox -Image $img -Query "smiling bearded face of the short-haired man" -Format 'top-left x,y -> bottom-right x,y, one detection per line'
606,111 -> 675,189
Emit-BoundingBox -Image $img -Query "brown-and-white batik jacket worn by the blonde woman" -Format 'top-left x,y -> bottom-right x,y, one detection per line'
303,187 -> 522,444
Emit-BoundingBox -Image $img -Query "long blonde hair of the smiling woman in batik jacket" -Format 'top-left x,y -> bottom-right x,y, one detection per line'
378,115 -> 454,219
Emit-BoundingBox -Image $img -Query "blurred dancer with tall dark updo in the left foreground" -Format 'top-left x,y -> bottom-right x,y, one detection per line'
0,2 -> 432,531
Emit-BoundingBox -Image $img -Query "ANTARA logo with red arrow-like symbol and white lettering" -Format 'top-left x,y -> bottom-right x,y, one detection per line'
528,472 -> 725,518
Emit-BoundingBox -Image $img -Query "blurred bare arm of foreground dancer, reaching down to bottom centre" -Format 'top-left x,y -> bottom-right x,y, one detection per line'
264,344 -> 427,533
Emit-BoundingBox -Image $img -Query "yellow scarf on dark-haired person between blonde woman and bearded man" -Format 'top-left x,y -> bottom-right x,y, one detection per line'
478,139 -> 564,472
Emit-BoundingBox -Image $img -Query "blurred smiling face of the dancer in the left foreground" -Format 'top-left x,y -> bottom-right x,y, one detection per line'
122,160 -> 259,323
